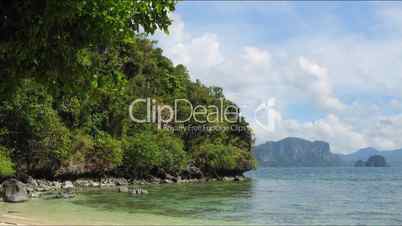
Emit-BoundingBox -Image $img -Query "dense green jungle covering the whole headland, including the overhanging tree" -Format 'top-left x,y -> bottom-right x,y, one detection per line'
0,0 -> 254,178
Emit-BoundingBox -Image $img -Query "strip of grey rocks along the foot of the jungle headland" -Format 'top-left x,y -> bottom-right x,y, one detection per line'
0,176 -> 246,203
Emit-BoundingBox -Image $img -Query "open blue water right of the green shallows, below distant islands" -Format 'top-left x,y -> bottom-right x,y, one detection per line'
245,167 -> 402,225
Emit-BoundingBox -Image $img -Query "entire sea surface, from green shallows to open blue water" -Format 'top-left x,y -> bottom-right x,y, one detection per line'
0,167 -> 402,225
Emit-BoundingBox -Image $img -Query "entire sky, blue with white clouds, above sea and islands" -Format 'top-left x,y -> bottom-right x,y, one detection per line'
155,1 -> 402,153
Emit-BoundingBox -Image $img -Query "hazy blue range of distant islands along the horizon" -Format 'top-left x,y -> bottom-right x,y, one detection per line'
253,137 -> 402,167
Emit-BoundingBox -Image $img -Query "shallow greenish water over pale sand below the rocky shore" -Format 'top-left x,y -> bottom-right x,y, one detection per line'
0,181 -> 251,225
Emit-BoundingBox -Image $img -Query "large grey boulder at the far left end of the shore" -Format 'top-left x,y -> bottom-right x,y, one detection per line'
1,179 -> 29,203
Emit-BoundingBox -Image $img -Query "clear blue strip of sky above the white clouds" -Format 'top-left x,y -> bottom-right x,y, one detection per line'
177,1 -> 390,42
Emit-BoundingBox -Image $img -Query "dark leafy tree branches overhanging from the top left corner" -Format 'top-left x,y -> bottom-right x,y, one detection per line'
0,0 -> 176,89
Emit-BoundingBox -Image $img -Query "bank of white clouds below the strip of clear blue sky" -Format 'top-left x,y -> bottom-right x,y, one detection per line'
158,11 -> 402,153
